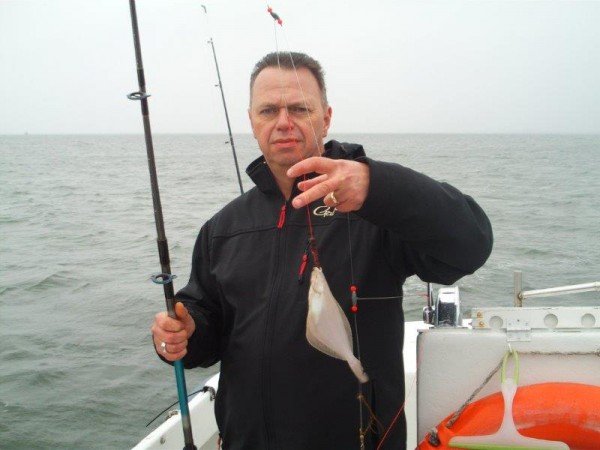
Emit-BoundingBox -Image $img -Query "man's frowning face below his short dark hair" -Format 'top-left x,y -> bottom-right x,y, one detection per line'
248,67 -> 331,174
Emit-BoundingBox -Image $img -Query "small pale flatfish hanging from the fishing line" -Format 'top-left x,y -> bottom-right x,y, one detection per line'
306,267 -> 369,383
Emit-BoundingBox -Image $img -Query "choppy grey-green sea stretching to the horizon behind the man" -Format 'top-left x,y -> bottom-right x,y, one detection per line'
0,134 -> 600,450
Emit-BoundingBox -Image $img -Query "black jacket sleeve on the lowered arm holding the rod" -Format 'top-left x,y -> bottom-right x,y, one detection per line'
162,221 -> 222,369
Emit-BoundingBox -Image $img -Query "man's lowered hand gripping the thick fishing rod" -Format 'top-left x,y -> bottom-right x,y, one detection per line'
150,302 -> 196,361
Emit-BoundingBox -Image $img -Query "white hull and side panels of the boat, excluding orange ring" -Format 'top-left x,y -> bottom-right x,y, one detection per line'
135,307 -> 600,450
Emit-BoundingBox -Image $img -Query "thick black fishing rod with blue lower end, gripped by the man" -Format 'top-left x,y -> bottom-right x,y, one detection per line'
127,0 -> 196,450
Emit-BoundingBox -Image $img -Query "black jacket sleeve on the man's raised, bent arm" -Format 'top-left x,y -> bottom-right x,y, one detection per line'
357,158 -> 493,284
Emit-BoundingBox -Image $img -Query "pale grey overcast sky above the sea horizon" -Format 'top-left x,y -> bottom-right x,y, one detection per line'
0,0 -> 600,134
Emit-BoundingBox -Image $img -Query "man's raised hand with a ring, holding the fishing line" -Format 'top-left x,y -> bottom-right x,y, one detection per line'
287,156 -> 370,212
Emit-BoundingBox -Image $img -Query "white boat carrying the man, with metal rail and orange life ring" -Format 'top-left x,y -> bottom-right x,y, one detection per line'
134,272 -> 600,450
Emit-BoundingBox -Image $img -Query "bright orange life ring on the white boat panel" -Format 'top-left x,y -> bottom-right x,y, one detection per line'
417,383 -> 600,450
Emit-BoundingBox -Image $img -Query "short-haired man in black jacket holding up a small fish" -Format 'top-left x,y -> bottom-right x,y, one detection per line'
152,53 -> 492,450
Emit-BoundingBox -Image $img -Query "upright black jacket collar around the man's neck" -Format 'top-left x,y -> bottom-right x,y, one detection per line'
246,140 -> 365,194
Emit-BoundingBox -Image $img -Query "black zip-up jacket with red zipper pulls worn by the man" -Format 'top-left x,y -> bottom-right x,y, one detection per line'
177,141 -> 492,450
